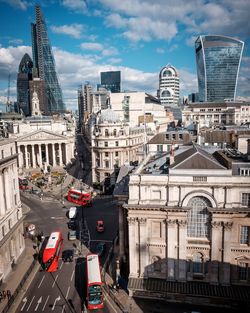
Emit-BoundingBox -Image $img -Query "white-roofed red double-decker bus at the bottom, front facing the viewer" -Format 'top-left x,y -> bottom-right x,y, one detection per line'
86,254 -> 104,310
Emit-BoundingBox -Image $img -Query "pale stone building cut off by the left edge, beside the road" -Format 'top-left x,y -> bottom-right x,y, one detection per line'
0,139 -> 25,285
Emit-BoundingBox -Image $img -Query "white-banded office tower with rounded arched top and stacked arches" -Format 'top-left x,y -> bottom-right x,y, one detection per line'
158,64 -> 180,107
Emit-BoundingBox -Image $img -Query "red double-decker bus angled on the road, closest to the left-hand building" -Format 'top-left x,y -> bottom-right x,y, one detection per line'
42,231 -> 63,272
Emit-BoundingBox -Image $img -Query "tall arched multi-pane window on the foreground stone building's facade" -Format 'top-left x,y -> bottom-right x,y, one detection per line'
187,197 -> 211,237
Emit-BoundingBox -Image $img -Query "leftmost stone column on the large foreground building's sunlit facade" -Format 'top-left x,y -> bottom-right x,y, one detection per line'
128,217 -> 138,277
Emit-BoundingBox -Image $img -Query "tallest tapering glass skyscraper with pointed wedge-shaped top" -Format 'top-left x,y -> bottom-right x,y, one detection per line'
31,6 -> 65,112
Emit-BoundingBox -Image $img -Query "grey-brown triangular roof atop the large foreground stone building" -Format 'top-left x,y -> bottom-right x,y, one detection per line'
171,145 -> 226,170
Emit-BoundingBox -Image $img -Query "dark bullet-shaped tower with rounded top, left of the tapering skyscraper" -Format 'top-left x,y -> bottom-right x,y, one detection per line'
17,53 -> 33,116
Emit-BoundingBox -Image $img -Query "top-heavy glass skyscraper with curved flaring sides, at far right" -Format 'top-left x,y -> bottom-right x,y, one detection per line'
195,35 -> 244,102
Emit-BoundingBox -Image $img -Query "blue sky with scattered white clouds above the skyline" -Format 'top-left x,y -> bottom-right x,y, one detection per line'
0,0 -> 250,110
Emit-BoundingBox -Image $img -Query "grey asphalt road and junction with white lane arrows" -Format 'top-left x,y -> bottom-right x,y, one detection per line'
16,191 -> 118,313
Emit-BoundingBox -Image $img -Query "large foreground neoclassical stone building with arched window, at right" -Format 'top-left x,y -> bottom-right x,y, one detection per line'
122,140 -> 250,305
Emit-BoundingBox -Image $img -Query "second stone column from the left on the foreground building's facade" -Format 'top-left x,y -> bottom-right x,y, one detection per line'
138,218 -> 148,276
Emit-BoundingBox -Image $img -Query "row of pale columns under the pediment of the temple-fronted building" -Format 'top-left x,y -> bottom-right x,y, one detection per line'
18,143 -> 69,168
